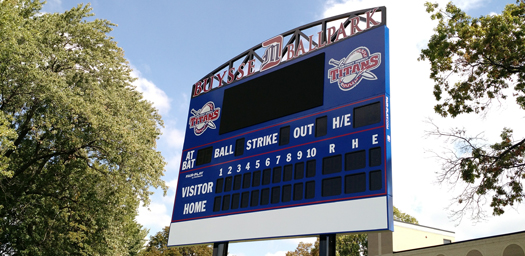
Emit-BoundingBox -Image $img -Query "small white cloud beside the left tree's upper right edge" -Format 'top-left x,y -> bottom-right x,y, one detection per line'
131,69 -> 171,115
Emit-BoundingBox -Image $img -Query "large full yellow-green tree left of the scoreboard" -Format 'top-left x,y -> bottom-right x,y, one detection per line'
0,0 -> 166,255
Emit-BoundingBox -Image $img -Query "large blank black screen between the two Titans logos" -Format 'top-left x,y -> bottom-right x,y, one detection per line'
219,53 -> 325,134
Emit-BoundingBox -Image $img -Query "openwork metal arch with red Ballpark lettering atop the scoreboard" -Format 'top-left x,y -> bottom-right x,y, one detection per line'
192,7 -> 386,97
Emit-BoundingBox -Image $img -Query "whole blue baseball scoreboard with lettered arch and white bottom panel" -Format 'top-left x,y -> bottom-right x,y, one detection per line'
168,7 -> 393,246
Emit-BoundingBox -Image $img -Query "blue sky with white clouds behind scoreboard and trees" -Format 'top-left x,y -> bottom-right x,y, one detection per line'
43,0 -> 525,256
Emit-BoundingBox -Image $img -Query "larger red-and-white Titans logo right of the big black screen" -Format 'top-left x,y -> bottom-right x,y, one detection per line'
328,46 -> 381,91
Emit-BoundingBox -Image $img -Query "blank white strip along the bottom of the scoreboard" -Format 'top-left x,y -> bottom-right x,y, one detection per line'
168,196 -> 390,246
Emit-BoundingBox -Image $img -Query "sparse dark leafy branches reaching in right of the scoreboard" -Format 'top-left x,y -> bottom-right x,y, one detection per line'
419,0 -> 525,219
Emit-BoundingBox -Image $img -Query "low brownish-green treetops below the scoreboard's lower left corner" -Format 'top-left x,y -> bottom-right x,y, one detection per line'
139,226 -> 213,256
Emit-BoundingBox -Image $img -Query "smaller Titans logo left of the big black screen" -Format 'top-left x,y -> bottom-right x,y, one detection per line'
190,101 -> 221,136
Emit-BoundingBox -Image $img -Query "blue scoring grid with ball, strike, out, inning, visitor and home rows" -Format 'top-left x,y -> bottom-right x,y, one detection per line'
177,96 -> 387,221
